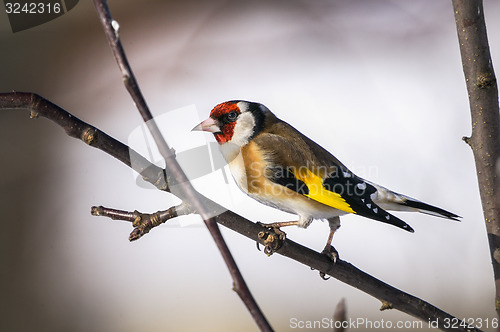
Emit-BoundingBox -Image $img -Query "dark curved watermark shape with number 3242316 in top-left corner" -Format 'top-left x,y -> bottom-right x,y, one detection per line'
4,0 -> 79,33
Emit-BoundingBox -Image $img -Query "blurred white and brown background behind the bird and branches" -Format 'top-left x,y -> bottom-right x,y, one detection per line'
0,0 -> 500,332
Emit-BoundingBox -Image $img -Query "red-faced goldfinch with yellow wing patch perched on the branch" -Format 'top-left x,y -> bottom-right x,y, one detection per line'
193,100 -> 460,261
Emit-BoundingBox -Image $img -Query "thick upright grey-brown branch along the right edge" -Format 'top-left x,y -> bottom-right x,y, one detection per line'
453,0 -> 500,316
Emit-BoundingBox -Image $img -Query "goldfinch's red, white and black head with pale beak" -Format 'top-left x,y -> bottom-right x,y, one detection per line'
193,100 -> 269,146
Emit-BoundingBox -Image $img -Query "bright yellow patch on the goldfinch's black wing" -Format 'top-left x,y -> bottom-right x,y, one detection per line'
293,170 -> 356,213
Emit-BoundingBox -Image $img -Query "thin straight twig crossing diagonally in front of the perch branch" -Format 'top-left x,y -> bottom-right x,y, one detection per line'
90,0 -> 272,331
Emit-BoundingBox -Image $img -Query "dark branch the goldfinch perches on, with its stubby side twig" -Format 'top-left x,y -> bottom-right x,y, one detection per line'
0,1 -> 488,331
